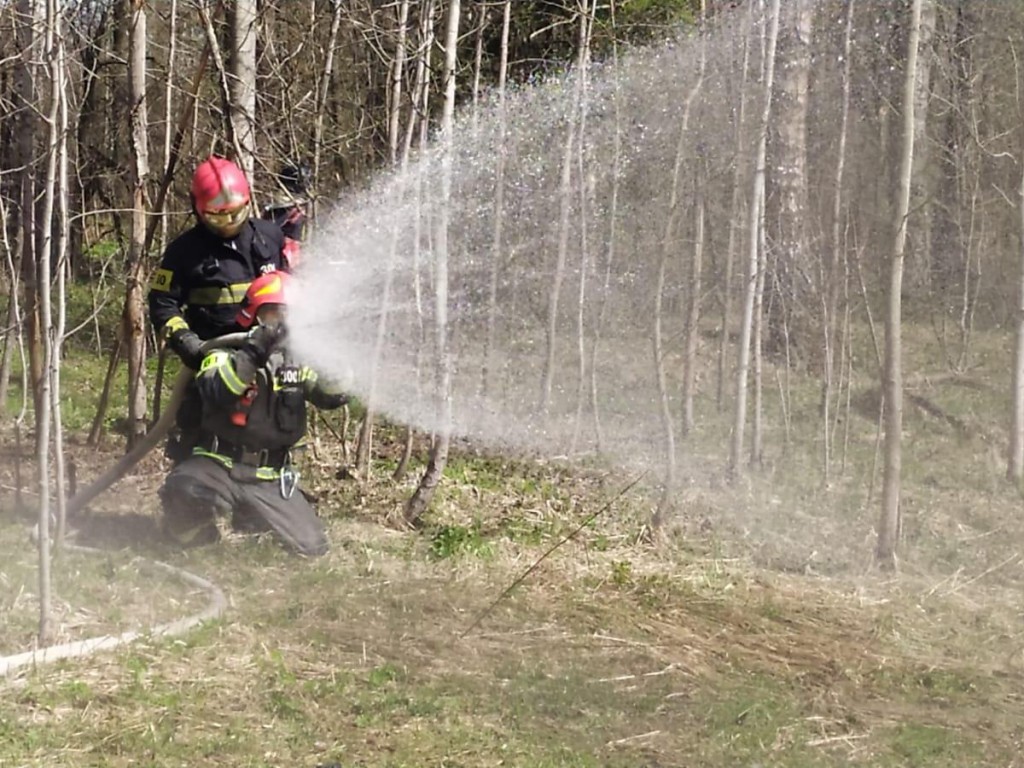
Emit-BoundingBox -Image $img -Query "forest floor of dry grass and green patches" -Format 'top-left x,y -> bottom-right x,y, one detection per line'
0,376 -> 1024,768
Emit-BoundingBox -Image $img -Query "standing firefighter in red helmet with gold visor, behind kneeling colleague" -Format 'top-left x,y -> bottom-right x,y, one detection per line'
148,157 -> 288,371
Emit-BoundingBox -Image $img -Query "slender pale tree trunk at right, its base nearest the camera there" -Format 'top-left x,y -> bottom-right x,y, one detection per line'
876,0 -> 924,570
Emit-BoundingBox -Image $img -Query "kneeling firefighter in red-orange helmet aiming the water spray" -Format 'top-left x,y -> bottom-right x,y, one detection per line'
160,271 -> 347,556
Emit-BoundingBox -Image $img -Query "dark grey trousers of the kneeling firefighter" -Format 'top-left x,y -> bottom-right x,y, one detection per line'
160,456 -> 328,557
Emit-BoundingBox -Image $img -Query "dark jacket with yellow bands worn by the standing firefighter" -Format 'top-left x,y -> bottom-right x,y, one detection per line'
148,218 -> 287,339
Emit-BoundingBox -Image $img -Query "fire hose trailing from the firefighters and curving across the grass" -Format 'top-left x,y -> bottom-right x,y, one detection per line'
0,333 -> 246,677
